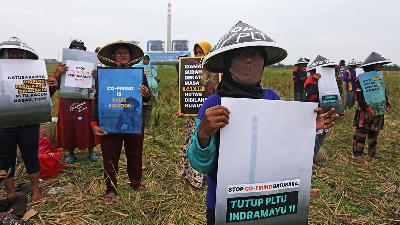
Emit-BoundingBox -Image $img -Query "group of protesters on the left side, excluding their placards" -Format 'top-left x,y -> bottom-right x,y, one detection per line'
0,38 -> 159,219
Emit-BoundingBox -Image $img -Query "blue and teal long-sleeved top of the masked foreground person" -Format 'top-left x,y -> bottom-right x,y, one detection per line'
187,89 -> 280,209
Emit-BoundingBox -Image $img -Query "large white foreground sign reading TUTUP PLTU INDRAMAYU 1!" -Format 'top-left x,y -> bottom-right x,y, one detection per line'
216,98 -> 317,225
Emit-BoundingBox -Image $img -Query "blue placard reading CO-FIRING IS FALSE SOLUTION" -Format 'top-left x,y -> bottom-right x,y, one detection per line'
98,68 -> 143,134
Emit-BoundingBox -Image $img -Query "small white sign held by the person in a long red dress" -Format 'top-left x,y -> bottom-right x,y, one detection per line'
65,60 -> 94,88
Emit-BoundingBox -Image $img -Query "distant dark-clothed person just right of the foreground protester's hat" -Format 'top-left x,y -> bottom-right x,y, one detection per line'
292,58 -> 310,101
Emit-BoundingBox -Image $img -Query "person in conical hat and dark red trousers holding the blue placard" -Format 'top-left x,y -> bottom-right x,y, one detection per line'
91,41 -> 151,204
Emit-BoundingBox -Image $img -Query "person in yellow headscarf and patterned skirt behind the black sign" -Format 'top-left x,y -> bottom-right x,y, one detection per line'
180,41 -> 212,188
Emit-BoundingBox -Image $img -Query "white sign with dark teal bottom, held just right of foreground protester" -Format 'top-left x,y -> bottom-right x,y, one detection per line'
315,66 -> 344,113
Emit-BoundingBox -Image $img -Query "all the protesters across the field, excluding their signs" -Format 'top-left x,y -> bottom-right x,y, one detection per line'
0,20 -> 390,224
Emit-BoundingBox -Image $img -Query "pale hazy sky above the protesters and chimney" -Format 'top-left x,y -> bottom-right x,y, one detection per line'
0,0 -> 400,64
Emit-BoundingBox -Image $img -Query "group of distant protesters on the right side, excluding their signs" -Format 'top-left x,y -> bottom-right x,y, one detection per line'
292,52 -> 391,165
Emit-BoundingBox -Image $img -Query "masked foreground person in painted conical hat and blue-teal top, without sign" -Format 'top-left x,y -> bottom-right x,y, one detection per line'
187,21 -> 338,224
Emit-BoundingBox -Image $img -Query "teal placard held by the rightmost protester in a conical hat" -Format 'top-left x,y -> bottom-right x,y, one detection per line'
358,71 -> 386,115
